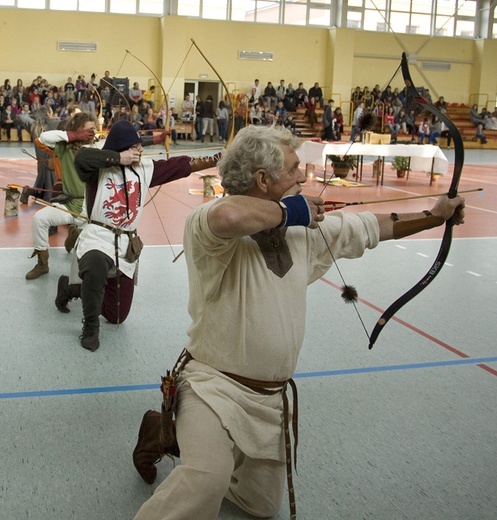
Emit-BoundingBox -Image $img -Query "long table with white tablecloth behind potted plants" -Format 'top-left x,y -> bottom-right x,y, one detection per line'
297,141 -> 449,184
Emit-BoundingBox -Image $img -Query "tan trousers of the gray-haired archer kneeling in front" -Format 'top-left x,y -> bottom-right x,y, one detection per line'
135,384 -> 286,520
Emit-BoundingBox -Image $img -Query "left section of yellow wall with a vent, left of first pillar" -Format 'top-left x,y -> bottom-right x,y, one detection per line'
0,9 -> 161,88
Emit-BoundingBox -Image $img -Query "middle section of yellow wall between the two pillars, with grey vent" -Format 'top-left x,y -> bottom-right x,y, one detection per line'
159,17 -> 328,108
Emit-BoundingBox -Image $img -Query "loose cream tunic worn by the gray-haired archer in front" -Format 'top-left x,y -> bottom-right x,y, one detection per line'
182,201 -> 379,460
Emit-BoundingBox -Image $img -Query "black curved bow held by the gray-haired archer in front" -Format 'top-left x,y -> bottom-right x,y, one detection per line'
369,53 -> 464,349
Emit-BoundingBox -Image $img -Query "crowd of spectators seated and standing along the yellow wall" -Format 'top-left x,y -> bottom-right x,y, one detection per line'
0,71 -> 497,145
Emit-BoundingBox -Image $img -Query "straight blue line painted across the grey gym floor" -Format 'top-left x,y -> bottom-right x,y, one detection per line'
0,356 -> 497,400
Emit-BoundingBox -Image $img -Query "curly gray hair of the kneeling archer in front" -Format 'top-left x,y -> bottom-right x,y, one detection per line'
217,125 -> 301,195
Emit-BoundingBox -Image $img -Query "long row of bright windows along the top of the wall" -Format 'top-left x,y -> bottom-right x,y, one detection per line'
0,0 -> 488,38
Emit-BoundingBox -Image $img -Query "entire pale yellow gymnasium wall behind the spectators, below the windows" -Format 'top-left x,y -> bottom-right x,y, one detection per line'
0,9 -> 497,111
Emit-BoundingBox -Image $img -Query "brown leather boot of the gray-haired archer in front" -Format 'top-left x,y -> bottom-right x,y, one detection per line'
133,410 -> 179,484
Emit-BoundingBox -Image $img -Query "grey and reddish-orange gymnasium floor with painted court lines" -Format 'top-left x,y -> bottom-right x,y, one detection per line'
0,139 -> 497,520
